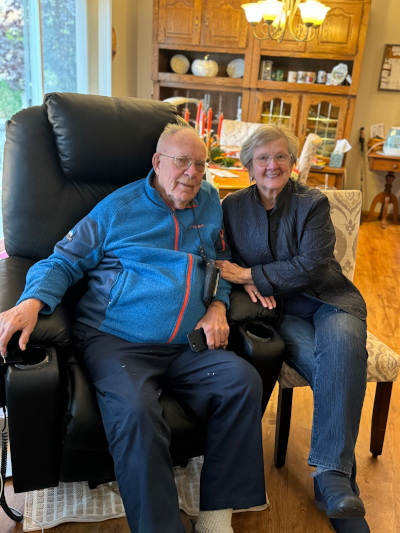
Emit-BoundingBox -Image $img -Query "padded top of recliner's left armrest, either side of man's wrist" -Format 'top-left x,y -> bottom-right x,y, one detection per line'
0,257 -> 71,345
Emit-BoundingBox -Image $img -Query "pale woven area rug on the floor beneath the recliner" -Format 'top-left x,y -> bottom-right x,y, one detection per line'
24,457 -> 269,531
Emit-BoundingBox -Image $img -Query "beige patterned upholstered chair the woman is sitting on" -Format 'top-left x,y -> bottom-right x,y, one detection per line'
275,190 -> 400,467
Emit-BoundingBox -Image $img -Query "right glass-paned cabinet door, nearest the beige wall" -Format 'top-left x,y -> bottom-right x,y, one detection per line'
299,96 -> 348,157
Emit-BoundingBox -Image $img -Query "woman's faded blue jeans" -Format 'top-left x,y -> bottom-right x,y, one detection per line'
278,304 -> 368,475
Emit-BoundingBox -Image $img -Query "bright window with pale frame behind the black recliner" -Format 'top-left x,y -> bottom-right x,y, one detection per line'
0,0 -> 112,244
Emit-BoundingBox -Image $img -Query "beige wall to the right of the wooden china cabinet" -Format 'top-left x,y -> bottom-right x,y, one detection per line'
346,0 -> 400,211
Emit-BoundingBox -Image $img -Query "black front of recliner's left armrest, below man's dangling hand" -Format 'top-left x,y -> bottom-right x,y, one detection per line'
6,346 -> 62,492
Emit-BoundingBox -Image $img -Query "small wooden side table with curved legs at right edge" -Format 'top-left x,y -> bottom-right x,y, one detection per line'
366,152 -> 400,229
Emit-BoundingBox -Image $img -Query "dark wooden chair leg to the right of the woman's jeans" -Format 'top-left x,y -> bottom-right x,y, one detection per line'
370,381 -> 393,457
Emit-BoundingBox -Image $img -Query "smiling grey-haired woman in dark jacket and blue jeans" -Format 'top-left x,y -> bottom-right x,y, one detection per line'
218,124 -> 369,533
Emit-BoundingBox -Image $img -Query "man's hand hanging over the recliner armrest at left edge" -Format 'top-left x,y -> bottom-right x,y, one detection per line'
0,298 -> 44,356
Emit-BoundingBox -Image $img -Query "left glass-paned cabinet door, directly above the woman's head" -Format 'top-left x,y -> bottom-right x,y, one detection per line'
249,91 -> 300,130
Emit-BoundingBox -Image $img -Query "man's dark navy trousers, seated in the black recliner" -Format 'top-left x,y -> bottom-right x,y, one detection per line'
74,323 -> 265,533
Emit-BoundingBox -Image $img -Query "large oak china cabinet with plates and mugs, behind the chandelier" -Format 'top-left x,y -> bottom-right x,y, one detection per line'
152,0 -> 371,189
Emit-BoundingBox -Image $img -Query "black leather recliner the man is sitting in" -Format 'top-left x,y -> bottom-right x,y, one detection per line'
0,93 -> 284,492
